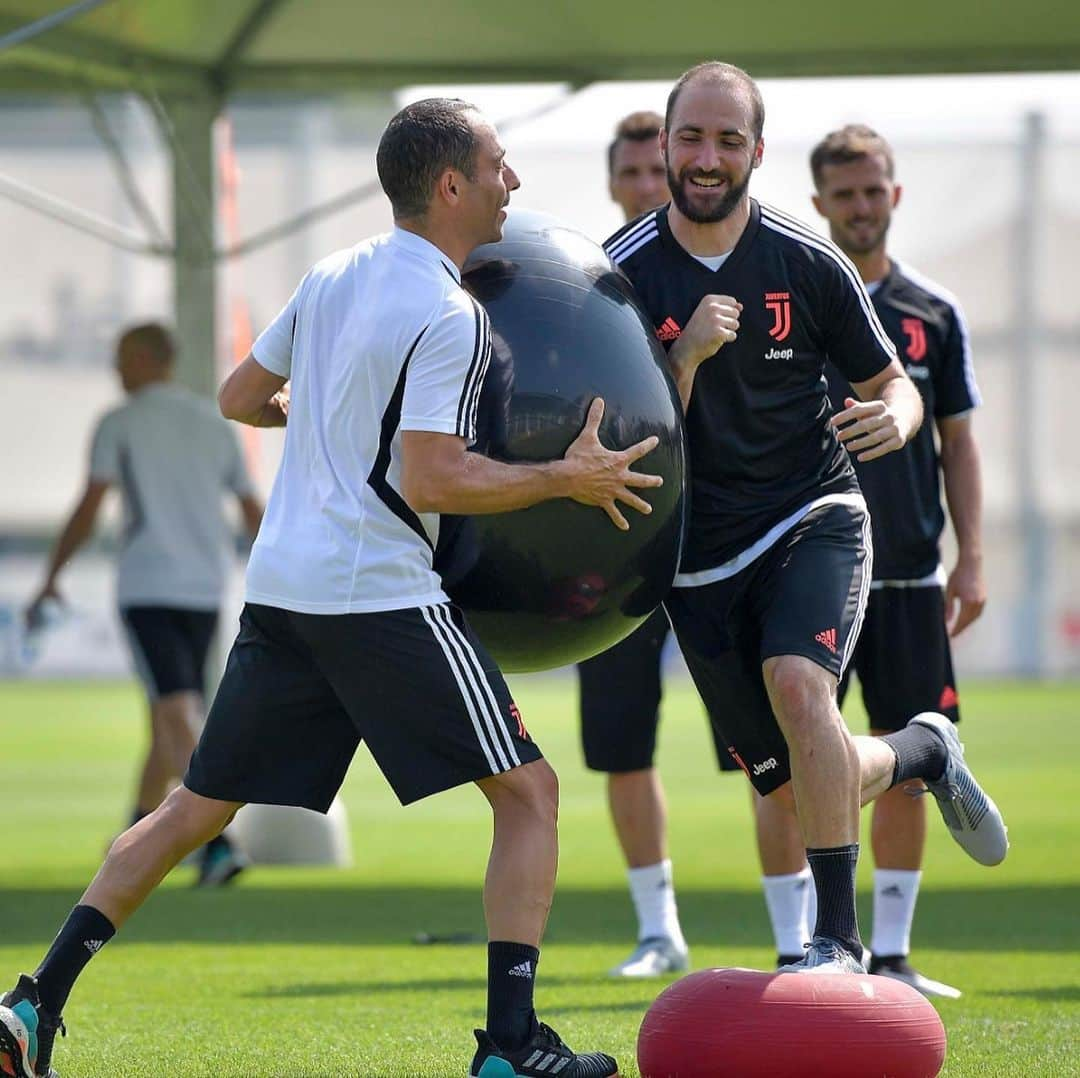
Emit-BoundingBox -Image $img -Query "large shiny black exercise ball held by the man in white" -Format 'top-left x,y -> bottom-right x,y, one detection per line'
436,211 -> 686,671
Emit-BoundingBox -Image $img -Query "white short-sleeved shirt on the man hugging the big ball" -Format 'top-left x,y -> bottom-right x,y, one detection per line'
246,229 -> 491,614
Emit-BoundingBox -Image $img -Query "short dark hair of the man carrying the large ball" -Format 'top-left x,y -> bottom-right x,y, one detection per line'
375,97 -> 476,219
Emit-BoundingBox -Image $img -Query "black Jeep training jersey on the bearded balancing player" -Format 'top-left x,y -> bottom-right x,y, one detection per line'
604,200 -> 895,574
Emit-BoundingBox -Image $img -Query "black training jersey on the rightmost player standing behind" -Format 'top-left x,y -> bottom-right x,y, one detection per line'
827,262 -> 982,580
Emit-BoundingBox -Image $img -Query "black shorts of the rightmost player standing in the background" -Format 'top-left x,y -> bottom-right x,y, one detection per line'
840,587 -> 960,731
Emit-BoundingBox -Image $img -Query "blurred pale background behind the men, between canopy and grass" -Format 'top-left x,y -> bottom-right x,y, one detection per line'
0,75 -> 1080,676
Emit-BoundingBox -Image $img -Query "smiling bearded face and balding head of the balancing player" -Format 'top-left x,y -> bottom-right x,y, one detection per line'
661,78 -> 764,225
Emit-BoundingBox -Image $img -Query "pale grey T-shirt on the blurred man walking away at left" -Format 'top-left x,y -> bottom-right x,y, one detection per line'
90,382 -> 253,610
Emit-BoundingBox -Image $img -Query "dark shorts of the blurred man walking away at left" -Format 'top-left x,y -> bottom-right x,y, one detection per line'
120,606 -> 217,700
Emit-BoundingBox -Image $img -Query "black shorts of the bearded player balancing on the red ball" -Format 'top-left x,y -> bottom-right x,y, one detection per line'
665,504 -> 872,795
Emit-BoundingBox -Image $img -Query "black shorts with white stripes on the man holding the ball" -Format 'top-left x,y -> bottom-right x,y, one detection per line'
184,603 -> 541,812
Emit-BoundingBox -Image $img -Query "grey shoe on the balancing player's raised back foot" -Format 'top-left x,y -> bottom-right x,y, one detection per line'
907,711 -> 1009,865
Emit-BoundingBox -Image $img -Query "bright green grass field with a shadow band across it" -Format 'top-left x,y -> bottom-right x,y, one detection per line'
0,677 -> 1080,1078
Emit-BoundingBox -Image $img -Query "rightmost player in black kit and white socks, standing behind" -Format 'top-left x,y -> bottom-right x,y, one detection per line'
759,124 -> 986,997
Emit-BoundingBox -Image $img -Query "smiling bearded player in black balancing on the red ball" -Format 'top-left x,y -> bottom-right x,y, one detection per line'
606,63 -> 1008,972
